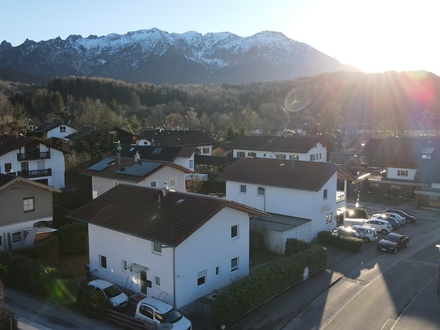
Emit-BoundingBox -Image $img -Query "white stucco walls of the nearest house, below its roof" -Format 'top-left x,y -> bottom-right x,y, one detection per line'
89,208 -> 249,308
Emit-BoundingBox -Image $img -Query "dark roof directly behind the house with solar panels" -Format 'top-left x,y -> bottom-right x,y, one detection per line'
110,145 -> 196,162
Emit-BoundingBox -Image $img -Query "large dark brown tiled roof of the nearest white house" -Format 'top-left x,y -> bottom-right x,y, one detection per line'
67,184 -> 268,246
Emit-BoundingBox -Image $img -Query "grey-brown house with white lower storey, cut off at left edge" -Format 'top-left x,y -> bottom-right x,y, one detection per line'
0,174 -> 61,251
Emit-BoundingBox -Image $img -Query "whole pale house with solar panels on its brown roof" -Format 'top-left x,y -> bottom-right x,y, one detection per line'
81,156 -> 192,198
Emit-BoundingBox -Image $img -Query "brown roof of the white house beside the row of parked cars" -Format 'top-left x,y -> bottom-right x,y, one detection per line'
217,158 -> 338,191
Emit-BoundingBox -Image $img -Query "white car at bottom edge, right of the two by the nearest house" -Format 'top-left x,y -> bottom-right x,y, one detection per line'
134,297 -> 192,330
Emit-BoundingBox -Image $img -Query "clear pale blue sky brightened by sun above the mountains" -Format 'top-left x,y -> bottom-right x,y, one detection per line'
0,0 -> 440,75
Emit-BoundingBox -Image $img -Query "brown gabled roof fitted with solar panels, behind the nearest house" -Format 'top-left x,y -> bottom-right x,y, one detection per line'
80,157 -> 193,183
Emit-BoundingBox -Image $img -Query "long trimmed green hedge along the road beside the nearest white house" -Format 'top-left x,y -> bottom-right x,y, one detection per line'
212,242 -> 328,326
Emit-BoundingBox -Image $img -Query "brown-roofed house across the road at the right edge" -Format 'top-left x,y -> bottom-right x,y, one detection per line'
361,136 -> 440,207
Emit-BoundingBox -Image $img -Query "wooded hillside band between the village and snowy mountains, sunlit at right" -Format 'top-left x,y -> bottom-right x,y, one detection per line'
0,71 -> 440,160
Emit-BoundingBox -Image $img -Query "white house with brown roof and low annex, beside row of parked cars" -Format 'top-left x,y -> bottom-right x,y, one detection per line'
218,158 -> 338,254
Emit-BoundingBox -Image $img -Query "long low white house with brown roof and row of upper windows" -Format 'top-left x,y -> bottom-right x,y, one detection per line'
227,135 -> 327,162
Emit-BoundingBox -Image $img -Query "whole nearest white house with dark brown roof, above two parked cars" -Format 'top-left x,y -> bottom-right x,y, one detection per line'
68,184 -> 268,310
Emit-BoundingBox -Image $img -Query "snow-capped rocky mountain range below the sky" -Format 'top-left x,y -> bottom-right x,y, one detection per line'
0,28 -> 354,84
